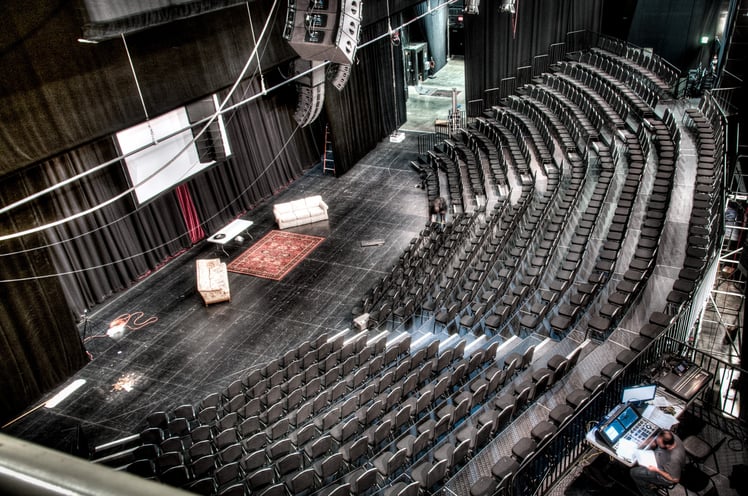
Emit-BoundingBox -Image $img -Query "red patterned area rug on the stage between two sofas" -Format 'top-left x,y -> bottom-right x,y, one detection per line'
227,230 -> 325,281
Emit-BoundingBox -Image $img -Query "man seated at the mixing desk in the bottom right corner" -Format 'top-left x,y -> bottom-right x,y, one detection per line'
630,430 -> 686,496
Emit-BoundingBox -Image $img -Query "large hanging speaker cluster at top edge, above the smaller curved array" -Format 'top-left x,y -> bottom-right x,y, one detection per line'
283,0 -> 361,64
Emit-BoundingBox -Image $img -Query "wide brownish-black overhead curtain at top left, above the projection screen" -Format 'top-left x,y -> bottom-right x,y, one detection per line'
0,0 -> 295,175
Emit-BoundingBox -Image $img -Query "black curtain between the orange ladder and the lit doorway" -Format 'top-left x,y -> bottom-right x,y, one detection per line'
325,17 -> 406,174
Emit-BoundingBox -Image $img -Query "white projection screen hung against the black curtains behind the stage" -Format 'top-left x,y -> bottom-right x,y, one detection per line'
117,100 -> 230,204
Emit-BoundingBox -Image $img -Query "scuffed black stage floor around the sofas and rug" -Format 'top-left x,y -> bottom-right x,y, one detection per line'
4,134 -> 428,451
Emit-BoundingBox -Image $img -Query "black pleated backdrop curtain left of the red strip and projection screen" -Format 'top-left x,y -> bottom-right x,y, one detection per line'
3,139 -> 189,319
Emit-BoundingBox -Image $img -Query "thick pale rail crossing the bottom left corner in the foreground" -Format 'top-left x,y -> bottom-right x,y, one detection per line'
0,434 -> 190,496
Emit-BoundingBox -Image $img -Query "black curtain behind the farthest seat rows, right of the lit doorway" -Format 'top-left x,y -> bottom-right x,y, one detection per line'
465,0 -> 602,108
